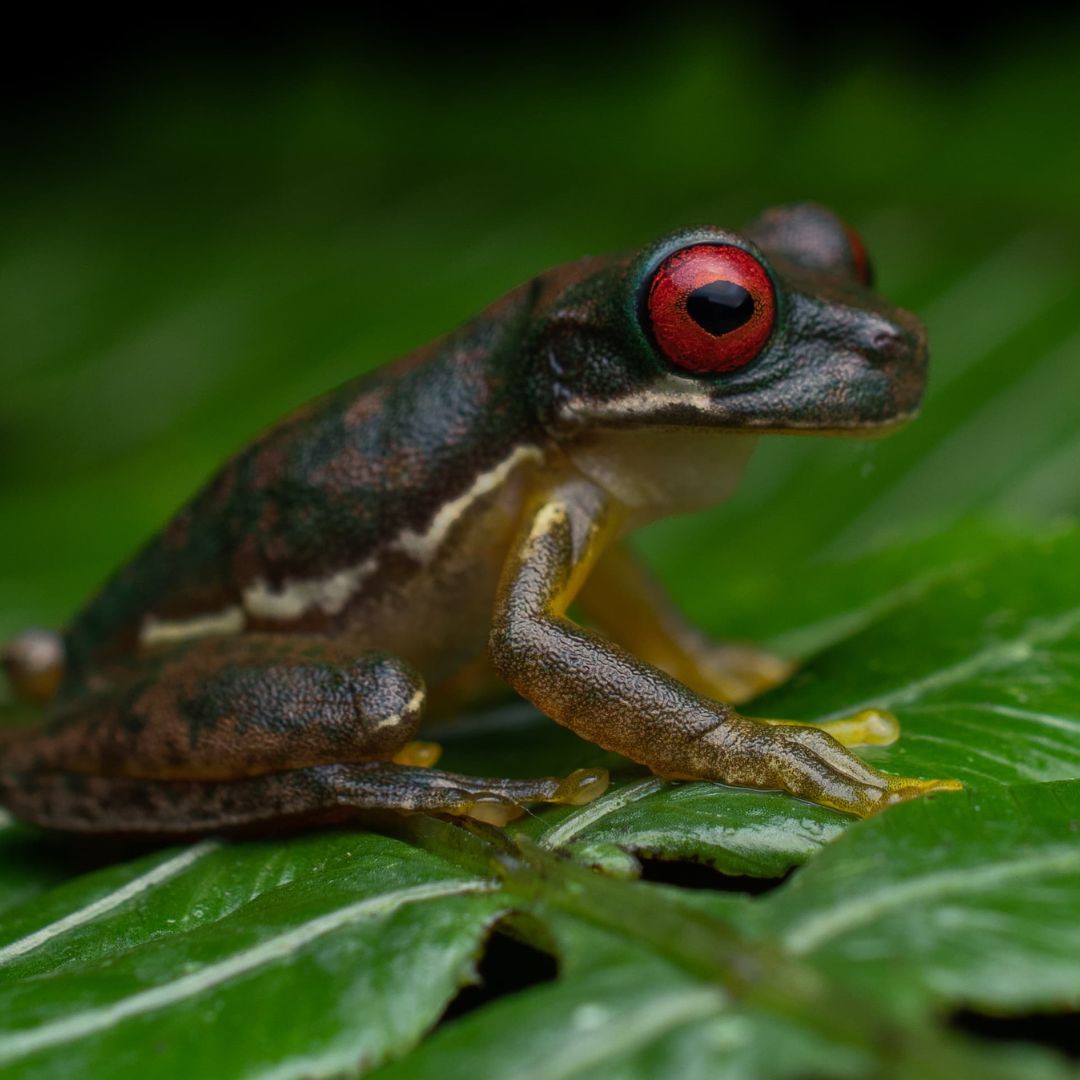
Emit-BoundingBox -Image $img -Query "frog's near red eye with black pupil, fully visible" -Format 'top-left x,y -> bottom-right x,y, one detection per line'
648,244 -> 777,374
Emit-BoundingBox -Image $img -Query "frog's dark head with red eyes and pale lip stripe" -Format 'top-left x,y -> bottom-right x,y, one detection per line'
530,204 -> 927,434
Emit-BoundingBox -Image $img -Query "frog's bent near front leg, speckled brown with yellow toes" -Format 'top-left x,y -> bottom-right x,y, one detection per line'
490,480 -> 959,816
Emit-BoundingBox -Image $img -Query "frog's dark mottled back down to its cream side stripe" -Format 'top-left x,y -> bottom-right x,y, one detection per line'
52,286 -> 536,684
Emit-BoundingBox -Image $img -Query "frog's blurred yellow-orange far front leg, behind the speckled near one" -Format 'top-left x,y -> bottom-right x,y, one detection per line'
578,543 -> 794,705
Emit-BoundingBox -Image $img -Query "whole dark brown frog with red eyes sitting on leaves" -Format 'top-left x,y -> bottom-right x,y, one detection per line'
0,203 -> 960,837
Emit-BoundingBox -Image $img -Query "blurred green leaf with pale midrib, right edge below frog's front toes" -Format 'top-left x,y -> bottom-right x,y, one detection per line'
754,781 -> 1080,1012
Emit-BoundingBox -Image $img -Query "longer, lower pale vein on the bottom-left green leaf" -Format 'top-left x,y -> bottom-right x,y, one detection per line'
0,879 -> 499,1064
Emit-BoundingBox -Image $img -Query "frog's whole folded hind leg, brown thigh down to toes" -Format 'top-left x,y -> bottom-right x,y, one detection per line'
0,635 -> 607,836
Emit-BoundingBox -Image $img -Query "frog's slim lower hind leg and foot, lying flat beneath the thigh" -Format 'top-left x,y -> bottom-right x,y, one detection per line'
0,761 -> 607,837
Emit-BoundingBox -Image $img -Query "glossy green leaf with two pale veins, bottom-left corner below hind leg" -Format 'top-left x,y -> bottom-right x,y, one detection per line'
0,833 -> 505,1077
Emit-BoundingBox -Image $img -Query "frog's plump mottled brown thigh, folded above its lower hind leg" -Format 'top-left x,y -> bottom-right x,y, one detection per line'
42,635 -> 424,780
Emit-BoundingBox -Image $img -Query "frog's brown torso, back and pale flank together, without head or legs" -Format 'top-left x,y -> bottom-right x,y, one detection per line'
66,286 -> 541,685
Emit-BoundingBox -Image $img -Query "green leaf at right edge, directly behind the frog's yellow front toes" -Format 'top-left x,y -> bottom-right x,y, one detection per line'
755,529 -> 1080,787
